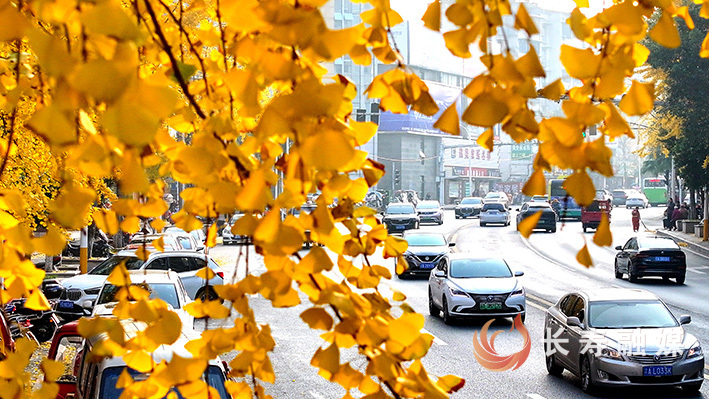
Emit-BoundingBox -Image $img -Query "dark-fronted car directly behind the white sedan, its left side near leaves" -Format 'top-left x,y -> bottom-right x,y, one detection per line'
397,231 -> 455,278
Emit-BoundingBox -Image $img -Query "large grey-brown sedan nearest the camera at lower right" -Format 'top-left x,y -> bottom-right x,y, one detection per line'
544,288 -> 704,392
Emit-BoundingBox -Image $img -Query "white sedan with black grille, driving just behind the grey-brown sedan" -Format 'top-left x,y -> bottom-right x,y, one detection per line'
428,253 -> 527,324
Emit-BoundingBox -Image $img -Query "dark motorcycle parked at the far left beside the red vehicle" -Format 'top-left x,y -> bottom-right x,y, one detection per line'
5,299 -> 59,342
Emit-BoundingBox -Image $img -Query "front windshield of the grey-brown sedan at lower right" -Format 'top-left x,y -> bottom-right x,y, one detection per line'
588,301 -> 677,329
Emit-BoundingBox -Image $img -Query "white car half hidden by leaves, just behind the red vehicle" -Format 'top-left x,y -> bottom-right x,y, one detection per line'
91,270 -> 194,328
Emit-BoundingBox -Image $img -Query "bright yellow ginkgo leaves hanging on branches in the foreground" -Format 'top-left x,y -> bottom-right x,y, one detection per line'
0,0 -> 700,398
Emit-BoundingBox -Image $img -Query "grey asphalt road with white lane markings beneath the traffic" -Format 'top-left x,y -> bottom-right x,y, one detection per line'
211,207 -> 709,399
